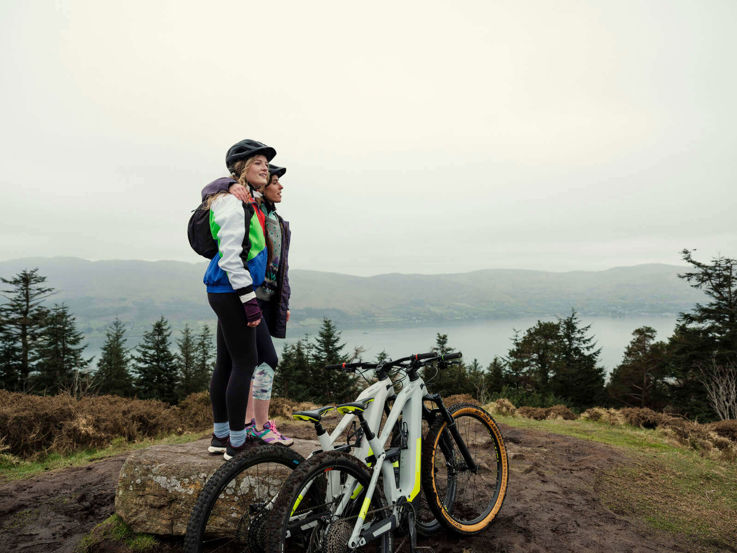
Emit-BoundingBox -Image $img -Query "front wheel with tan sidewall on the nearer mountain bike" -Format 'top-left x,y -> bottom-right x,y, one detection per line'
422,403 -> 509,534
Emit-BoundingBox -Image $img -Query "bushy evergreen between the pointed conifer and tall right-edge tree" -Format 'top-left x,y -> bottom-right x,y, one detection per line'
607,326 -> 667,410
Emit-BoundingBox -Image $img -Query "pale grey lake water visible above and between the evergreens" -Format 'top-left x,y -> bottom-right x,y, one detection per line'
275,315 -> 676,373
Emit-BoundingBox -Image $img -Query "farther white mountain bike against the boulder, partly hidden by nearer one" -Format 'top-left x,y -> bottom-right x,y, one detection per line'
184,355 -> 459,553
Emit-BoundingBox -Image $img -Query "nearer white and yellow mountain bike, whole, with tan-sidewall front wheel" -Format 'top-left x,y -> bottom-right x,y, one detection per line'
264,353 -> 509,553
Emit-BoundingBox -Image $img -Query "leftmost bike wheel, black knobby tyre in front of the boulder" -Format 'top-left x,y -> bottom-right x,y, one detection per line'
184,445 -> 304,553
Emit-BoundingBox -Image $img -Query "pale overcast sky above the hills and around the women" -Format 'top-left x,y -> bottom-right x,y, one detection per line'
0,0 -> 737,275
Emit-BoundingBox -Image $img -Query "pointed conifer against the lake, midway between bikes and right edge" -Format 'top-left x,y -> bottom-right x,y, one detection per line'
550,311 -> 605,409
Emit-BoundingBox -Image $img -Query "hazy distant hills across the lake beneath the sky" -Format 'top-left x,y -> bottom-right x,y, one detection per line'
0,257 -> 704,347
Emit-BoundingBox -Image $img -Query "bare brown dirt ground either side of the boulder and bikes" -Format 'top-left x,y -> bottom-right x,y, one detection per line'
0,425 -> 708,553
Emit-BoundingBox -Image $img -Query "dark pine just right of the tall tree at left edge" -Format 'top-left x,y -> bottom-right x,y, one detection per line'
29,304 -> 92,394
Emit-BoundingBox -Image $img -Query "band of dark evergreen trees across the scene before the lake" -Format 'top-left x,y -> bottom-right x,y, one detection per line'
0,250 -> 737,422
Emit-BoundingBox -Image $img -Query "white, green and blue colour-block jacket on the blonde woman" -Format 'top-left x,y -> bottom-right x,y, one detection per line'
202,178 -> 268,303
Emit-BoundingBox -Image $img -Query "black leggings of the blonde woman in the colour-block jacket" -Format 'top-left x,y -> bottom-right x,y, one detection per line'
207,293 -> 258,430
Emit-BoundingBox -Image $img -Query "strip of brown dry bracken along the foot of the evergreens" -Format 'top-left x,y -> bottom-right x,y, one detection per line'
0,390 -> 737,464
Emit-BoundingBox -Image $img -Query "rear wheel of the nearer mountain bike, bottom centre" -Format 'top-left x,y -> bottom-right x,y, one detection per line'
264,451 -> 393,553
